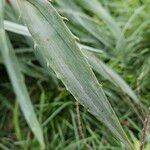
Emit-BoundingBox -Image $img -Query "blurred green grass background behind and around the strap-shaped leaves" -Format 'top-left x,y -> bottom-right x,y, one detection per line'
0,0 -> 150,150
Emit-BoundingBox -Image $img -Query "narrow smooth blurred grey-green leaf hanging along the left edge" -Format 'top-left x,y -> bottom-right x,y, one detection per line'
0,0 -> 44,147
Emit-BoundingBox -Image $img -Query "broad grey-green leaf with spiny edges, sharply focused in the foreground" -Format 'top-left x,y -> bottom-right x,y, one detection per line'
19,0 -> 132,149
